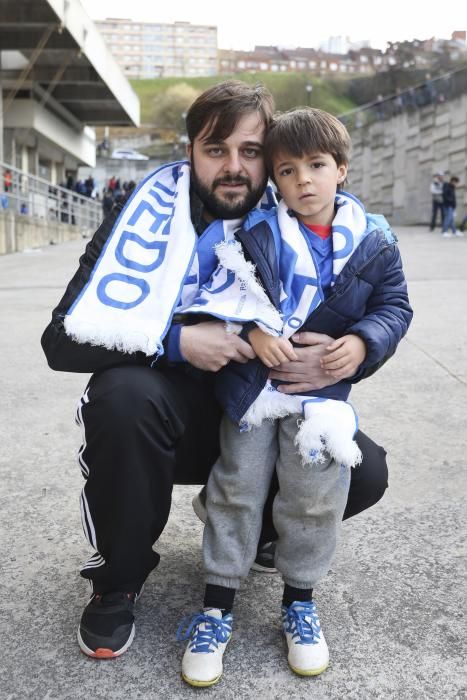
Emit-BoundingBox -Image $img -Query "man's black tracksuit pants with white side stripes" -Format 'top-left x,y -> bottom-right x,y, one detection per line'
77,366 -> 387,592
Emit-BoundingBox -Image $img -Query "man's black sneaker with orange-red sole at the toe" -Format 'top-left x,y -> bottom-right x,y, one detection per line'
78,590 -> 141,659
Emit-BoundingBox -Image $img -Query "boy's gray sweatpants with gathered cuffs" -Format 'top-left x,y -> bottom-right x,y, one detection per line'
203,414 -> 350,588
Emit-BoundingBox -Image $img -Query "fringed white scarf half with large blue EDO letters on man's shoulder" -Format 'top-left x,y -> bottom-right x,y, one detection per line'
65,163 -> 197,356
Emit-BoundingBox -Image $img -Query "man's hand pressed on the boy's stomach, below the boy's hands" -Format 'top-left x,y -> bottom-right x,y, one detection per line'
269,331 -> 337,394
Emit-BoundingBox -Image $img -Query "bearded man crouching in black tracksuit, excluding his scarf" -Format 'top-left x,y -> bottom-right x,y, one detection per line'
42,81 -> 387,658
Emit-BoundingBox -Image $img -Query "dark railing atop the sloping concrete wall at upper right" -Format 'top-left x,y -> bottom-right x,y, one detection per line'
338,66 -> 467,129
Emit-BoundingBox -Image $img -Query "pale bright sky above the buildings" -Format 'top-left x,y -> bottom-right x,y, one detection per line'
81,0 -> 467,50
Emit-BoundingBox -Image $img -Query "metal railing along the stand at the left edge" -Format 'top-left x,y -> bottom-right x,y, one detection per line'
0,162 -> 102,235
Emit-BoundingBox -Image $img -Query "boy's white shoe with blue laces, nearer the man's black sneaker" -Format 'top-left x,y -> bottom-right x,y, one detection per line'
177,608 -> 233,688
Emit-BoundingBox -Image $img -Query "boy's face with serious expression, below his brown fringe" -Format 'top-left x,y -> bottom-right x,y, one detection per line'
273,153 -> 347,226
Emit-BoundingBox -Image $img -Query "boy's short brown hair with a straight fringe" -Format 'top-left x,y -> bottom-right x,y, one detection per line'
264,107 -> 351,177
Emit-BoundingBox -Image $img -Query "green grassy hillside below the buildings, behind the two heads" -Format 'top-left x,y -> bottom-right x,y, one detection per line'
131,73 -> 356,124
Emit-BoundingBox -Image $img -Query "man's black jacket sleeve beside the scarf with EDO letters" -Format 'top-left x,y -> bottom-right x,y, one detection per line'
41,202 -> 155,372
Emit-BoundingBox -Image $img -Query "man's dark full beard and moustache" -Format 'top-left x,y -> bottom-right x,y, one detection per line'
191,158 -> 268,219
